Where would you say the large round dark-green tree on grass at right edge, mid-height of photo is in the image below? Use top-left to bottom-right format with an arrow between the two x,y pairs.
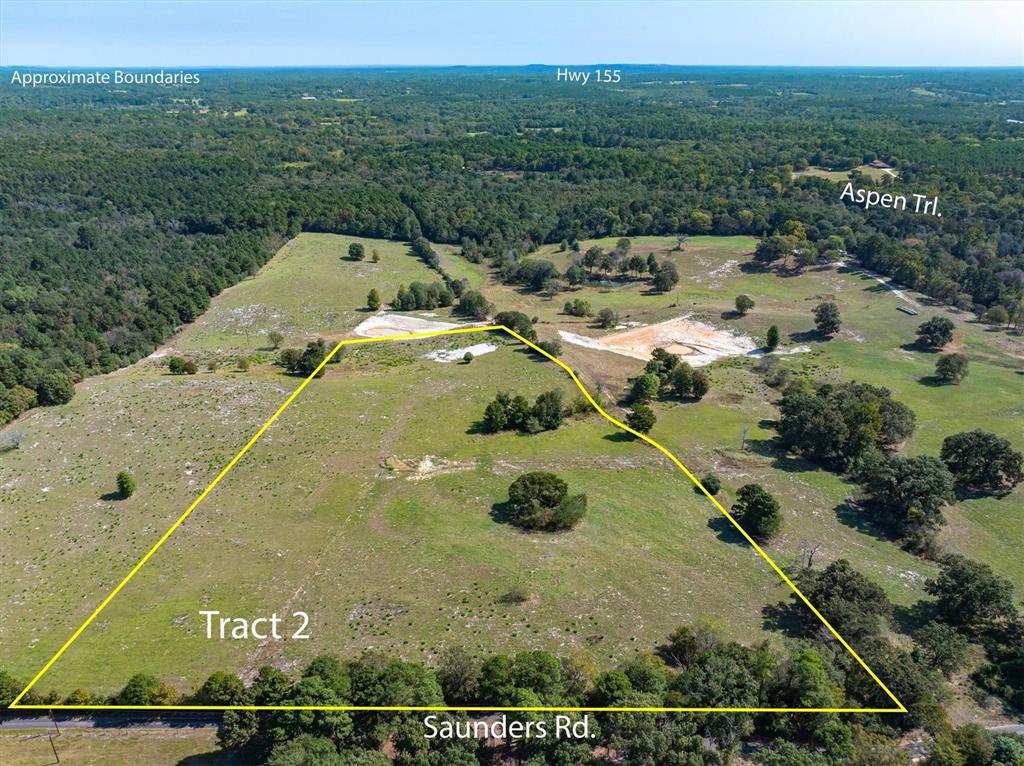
939,429 -> 1024,494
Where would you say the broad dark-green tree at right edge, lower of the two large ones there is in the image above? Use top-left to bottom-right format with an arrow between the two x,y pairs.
925,555 -> 1017,631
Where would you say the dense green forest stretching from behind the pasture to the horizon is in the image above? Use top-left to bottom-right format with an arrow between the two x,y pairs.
0,68 -> 1024,420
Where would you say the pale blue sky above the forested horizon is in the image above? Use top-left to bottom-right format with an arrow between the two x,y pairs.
0,0 -> 1024,68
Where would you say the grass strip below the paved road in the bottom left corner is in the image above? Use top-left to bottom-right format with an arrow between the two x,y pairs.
0,728 -> 224,766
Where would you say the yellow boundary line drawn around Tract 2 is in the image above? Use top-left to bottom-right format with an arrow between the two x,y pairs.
9,325 -> 907,713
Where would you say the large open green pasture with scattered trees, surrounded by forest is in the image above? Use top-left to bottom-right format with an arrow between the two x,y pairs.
0,235 -> 1024,704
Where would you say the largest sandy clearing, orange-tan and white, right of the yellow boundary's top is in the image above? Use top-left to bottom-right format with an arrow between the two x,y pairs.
558,314 -> 758,367
